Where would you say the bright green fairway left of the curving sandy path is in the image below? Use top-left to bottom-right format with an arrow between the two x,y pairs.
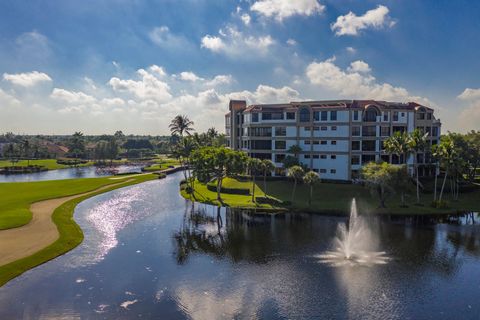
0,177 -> 152,230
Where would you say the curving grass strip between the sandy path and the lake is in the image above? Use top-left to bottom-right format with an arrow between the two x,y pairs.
0,174 -> 158,286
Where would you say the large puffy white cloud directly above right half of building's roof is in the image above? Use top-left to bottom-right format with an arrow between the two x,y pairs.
306,58 -> 432,105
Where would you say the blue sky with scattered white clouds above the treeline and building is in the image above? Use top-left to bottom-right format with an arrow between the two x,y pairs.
0,0 -> 480,135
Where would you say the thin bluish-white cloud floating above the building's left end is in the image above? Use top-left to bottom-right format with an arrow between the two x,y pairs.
201,26 -> 275,57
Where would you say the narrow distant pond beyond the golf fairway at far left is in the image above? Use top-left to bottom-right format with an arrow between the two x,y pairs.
0,166 -> 141,182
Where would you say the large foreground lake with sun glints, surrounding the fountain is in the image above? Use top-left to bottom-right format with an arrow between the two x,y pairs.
0,173 -> 480,319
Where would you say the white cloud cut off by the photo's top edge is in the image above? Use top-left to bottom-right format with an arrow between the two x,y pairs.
250,0 -> 325,21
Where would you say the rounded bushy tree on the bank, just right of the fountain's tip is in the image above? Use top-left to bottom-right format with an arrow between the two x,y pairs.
362,162 -> 396,208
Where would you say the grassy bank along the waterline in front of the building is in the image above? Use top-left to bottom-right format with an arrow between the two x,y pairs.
181,178 -> 480,214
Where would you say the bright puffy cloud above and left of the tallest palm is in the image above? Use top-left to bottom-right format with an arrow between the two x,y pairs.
108,68 -> 172,102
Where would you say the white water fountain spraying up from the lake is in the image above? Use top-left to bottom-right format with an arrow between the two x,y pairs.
317,198 -> 389,266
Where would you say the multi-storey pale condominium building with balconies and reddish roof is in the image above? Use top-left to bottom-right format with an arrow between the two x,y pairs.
225,100 -> 441,181
